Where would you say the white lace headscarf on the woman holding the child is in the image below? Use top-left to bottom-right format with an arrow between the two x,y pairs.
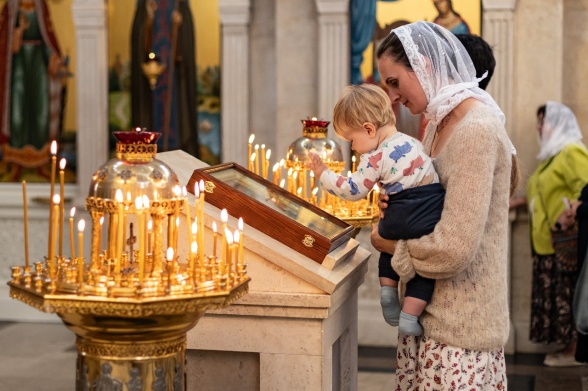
392,21 -> 516,155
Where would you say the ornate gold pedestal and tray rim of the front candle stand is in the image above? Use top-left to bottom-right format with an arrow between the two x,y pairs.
8,277 -> 250,391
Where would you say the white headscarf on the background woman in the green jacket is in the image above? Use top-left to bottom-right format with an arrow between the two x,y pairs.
537,101 -> 582,161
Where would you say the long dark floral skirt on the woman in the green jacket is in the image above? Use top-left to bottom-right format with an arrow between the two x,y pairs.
530,254 -> 577,344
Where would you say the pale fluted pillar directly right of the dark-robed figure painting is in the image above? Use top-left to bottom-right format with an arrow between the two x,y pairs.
219,0 -> 250,166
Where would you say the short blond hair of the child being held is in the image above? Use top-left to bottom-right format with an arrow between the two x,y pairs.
333,84 -> 396,138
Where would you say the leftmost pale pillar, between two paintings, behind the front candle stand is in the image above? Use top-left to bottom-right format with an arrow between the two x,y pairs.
72,0 -> 108,206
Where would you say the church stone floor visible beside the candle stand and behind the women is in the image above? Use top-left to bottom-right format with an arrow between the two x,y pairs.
0,322 -> 588,391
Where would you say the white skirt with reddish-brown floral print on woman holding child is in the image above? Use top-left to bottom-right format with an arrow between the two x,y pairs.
396,335 -> 507,391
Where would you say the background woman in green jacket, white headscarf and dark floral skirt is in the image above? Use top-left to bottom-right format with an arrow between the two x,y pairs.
526,101 -> 588,367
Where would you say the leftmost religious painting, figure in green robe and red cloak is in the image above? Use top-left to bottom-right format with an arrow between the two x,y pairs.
0,0 -> 76,182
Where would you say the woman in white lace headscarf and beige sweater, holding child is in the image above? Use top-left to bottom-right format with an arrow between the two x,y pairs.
372,22 -> 517,390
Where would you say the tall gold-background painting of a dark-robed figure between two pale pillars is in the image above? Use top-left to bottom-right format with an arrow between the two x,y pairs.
108,0 -> 221,164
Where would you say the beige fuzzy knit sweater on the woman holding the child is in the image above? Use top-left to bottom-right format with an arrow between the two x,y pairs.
392,106 -> 512,350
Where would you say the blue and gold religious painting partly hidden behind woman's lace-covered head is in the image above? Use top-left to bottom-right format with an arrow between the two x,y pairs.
350,0 -> 482,139
